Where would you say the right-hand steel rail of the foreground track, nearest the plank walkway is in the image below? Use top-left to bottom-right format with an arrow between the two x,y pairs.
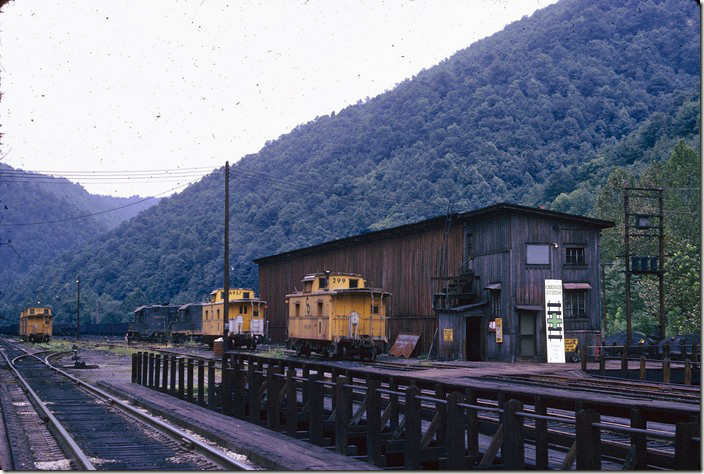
40,353 -> 256,471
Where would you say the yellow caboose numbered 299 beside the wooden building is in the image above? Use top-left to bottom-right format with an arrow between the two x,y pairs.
286,271 -> 391,360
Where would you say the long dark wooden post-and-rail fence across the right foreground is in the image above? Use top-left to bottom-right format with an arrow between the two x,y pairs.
132,353 -> 701,470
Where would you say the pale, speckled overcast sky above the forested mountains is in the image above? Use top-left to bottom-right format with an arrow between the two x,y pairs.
0,0 -> 556,196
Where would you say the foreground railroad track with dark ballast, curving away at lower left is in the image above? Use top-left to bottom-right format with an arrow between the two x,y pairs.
0,341 -> 256,470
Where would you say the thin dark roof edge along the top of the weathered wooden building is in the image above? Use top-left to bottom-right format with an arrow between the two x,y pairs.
254,203 -> 615,264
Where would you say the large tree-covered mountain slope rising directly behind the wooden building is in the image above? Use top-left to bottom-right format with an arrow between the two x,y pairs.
0,0 -> 700,326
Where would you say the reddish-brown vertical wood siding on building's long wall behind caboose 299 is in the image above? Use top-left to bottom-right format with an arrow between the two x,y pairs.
259,222 -> 464,352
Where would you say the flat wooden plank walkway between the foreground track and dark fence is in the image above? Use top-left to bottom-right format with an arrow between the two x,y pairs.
98,382 -> 378,471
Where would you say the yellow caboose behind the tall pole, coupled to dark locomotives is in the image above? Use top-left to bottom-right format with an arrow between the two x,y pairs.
202,288 -> 267,348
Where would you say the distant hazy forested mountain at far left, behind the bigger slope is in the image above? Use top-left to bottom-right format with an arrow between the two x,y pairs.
0,163 -> 157,301
